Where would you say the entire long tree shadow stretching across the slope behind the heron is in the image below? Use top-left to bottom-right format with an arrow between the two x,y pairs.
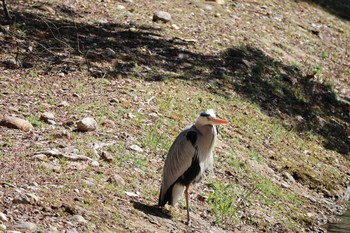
0,1 -> 350,155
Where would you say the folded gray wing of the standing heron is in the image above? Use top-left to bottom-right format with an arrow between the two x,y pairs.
160,127 -> 198,203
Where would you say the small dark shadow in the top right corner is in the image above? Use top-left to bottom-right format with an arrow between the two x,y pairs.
302,0 -> 350,20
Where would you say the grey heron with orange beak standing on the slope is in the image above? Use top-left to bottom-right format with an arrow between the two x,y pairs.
158,109 -> 228,224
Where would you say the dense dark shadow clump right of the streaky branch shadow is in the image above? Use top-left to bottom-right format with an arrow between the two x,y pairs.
219,47 -> 350,155
